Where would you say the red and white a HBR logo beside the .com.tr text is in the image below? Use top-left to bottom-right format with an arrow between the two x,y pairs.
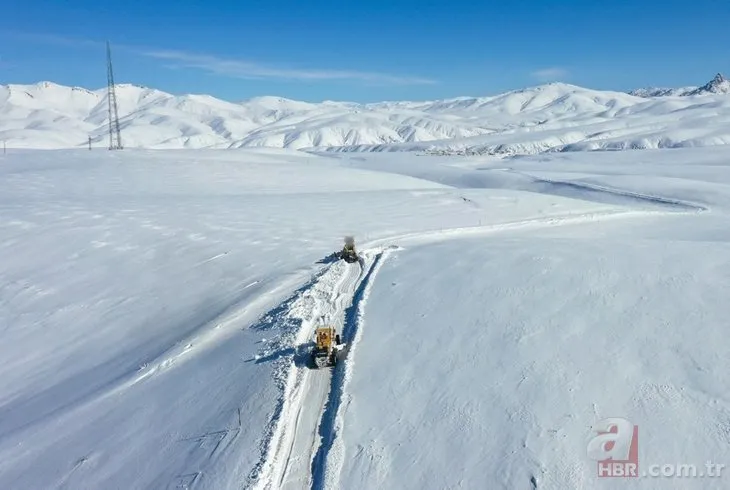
588,417 -> 639,478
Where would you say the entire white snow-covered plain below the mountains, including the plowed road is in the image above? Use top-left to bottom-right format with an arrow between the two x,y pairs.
0,146 -> 730,489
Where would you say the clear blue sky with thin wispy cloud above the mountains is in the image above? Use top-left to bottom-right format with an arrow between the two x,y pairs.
0,0 -> 730,101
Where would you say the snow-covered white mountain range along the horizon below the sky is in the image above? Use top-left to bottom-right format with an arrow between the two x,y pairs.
0,75 -> 730,154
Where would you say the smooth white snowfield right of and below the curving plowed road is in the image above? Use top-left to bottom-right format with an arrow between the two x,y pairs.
329,219 -> 730,489
